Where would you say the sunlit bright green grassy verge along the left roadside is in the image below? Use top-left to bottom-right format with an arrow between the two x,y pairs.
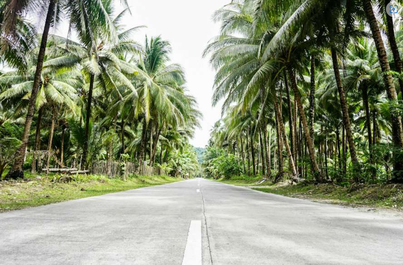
0,175 -> 180,212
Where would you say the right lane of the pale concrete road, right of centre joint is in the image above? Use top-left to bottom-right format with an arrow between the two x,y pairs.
203,182 -> 403,265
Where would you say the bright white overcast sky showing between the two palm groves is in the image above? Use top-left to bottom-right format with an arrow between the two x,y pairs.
52,0 -> 230,147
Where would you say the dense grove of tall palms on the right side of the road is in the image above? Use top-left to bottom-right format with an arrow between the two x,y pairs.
205,0 -> 403,183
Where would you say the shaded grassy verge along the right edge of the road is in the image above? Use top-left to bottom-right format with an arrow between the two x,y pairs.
255,183 -> 403,210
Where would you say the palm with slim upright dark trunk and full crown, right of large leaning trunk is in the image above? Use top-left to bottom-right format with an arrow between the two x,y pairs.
46,10 -> 141,166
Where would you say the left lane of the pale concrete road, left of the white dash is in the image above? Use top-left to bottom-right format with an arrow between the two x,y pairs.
0,181 -> 202,265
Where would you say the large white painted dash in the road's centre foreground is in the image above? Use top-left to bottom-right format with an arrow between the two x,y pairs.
182,220 -> 202,265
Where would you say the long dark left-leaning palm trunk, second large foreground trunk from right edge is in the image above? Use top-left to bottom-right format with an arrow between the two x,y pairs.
331,47 -> 360,181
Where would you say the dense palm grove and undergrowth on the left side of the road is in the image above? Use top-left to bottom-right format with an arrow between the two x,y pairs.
0,0 -> 201,178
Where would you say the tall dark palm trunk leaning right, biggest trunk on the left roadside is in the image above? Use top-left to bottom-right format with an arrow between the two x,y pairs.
5,0 -> 56,179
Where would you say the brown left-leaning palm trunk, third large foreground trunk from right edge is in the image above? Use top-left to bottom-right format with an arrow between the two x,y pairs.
288,66 -> 322,182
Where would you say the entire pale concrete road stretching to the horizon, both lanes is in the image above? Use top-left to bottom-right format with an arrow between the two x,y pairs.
0,180 -> 403,265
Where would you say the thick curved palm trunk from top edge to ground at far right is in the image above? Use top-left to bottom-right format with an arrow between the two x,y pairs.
363,0 -> 403,183
